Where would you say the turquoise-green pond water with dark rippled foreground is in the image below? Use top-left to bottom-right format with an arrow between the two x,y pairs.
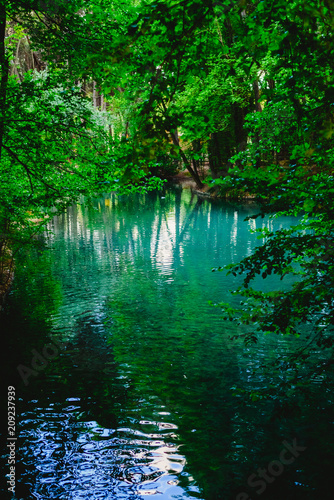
2,187 -> 334,500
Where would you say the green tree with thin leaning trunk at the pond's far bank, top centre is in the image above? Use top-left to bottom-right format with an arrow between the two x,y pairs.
88,1 -> 236,187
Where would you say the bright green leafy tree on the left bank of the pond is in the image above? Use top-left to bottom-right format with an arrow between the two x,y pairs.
0,0 -> 162,296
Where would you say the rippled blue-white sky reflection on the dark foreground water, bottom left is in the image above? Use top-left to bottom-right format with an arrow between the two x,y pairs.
20,398 -> 187,499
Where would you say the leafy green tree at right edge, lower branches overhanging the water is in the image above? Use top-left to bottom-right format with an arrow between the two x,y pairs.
211,1 -> 334,392
